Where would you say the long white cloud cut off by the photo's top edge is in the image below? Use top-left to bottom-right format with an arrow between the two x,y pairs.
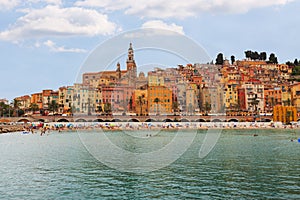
75,0 -> 295,19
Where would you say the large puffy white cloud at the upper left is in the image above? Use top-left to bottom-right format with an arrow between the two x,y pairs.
0,5 -> 117,42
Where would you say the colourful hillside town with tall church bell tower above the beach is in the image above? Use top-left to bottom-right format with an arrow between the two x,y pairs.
0,43 -> 300,123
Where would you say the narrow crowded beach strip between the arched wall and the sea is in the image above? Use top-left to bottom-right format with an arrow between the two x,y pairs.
0,122 -> 300,134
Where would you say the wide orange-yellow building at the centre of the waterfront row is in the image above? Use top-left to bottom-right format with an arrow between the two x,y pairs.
148,86 -> 172,115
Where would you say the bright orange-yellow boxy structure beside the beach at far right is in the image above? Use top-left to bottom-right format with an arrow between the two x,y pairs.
273,105 -> 298,124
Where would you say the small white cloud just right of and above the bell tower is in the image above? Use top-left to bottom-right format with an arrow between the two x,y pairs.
142,20 -> 184,35
